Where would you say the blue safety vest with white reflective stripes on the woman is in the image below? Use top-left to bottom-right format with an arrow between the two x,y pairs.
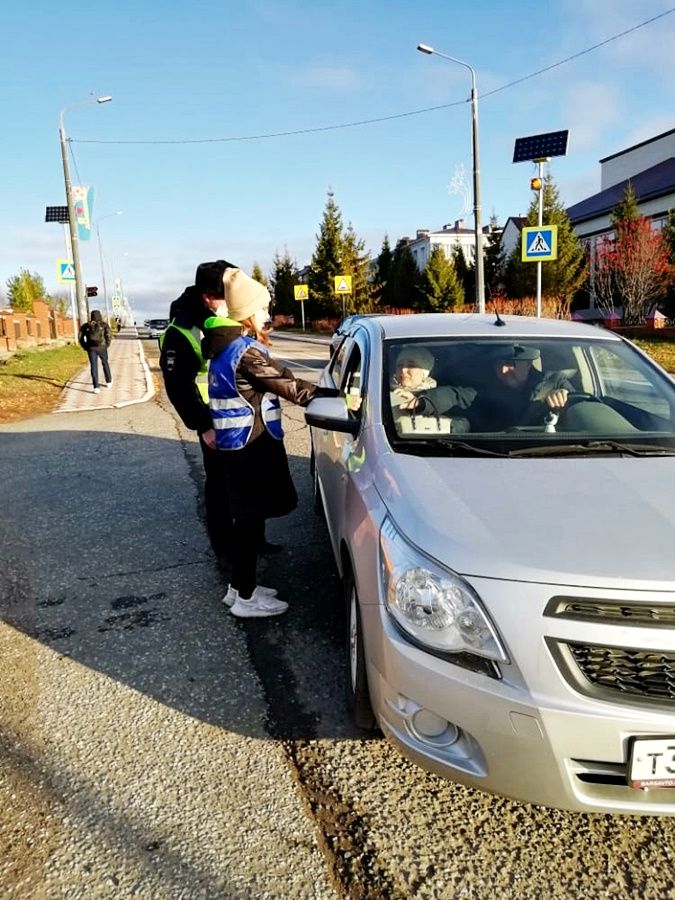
209,335 -> 284,450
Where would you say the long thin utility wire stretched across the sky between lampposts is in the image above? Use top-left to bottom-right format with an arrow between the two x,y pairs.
74,6 -> 675,144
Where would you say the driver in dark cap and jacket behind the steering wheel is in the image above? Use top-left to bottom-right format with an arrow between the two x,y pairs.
468,344 -> 574,431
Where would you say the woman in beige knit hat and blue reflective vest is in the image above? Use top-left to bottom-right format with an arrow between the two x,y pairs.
202,268 -> 336,617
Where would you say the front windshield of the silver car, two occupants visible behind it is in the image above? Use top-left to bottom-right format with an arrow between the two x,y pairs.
383,336 -> 675,455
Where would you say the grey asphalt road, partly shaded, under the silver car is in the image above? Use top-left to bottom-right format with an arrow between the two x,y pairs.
0,338 -> 675,898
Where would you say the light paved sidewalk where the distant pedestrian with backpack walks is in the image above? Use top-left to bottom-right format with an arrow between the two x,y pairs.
54,328 -> 155,413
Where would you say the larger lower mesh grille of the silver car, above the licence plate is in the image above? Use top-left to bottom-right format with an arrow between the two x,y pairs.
566,643 -> 675,702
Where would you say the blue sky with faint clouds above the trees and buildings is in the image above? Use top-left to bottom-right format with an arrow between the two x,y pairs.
0,0 -> 675,320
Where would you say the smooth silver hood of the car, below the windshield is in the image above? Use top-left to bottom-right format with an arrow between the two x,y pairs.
375,453 -> 675,590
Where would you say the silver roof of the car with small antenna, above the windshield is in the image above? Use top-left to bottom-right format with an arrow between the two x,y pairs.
354,313 -> 621,342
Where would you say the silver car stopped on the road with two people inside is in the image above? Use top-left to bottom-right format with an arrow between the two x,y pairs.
306,314 -> 675,815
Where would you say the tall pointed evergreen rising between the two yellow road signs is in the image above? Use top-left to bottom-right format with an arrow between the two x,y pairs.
307,191 -> 349,318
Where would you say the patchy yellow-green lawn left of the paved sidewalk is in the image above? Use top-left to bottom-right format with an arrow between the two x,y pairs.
0,344 -> 88,422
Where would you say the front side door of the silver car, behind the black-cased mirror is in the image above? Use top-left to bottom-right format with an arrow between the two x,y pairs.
313,333 -> 366,559
